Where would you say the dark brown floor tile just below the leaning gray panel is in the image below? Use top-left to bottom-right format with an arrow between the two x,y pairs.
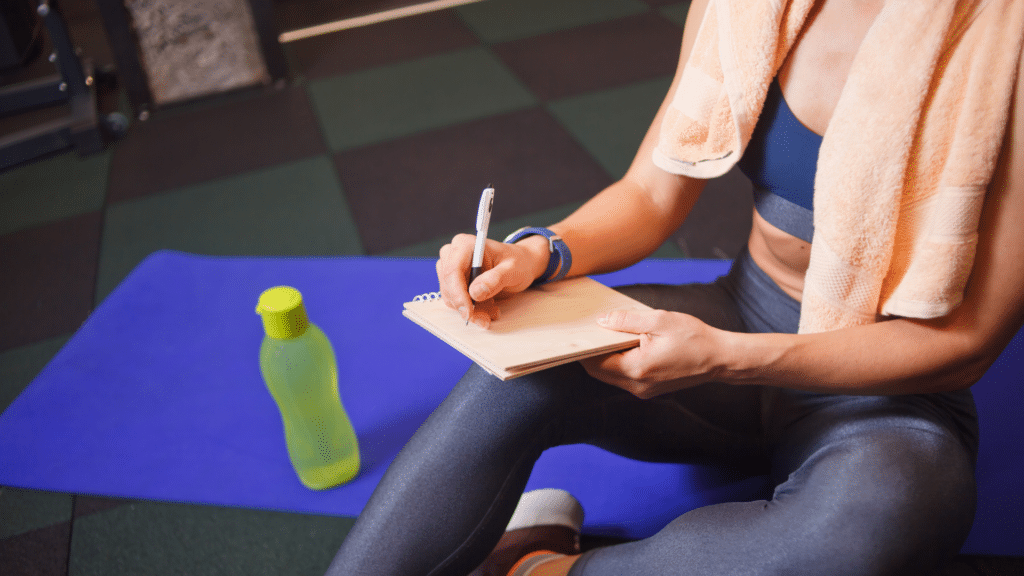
110,87 -> 326,201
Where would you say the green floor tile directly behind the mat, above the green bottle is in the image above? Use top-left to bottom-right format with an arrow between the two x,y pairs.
96,157 -> 362,302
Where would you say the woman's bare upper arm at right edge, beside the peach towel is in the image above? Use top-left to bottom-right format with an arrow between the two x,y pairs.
943,51 -> 1024,369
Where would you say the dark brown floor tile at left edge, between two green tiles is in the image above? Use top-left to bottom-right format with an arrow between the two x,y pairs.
0,212 -> 101,351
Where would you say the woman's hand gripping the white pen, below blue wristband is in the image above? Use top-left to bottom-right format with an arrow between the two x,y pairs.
437,234 -> 550,328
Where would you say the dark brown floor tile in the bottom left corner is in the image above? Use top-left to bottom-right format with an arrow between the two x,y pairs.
0,522 -> 71,576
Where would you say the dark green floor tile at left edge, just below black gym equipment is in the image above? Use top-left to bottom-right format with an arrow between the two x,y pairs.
0,153 -> 111,234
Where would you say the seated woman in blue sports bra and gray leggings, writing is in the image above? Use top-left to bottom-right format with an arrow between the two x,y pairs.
330,0 -> 1024,576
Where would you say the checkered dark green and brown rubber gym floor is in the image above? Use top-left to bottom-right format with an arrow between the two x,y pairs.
0,0 -> 1024,576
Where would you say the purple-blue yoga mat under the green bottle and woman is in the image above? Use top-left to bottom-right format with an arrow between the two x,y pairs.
0,251 -> 1024,554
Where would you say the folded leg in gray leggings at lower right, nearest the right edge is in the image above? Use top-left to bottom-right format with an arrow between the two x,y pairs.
570,399 -> 975,576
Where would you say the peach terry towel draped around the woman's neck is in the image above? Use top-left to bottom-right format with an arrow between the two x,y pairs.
653,0 -> 1024,333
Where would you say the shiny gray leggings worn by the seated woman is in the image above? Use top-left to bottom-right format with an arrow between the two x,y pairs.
328,253 -> 978,576
